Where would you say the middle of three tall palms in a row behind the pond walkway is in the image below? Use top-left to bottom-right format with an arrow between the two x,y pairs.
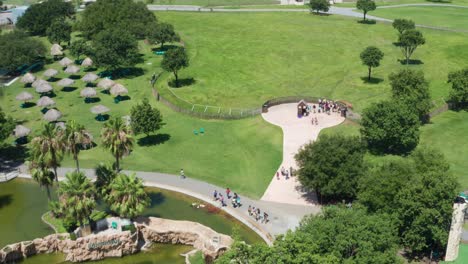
64,120 -> 92,172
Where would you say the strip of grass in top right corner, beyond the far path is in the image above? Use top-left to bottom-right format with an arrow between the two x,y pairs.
370,6 -> 468,30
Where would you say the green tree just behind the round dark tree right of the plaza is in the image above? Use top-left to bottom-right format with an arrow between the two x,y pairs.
389,69 -> 432,123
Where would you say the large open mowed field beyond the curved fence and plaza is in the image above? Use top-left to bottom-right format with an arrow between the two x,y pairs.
156,12 -> 468,112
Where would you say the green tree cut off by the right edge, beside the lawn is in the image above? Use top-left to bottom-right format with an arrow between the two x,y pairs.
448,68 -> 468,108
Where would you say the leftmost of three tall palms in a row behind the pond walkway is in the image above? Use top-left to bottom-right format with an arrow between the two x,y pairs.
31,123 -> 65,181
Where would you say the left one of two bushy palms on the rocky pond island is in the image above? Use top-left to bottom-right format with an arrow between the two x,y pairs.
58,172 -> 96,226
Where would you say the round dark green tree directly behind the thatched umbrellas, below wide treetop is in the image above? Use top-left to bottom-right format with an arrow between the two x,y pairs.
92,28 -> 139,70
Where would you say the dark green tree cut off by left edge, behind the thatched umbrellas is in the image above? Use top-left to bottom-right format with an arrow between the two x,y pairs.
0,31 -> 46,71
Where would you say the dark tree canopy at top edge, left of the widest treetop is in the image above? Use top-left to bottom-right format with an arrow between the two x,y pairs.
16,0 -> 75,36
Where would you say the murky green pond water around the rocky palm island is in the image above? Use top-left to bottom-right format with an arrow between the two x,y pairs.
0,179 -> 263,264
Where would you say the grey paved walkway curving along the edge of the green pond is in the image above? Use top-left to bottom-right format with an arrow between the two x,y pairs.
15,166 -> 320,242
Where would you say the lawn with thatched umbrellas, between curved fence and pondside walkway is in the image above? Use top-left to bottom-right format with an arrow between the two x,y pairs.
0,42 -> 282,198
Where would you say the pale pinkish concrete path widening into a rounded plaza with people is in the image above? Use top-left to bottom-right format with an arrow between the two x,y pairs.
262,103 -> 345,206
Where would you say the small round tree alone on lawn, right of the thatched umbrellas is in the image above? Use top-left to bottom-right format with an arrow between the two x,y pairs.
130,98 -> 164,136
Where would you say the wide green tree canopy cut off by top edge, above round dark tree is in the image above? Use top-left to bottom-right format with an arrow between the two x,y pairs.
78,0 -> 156,39
